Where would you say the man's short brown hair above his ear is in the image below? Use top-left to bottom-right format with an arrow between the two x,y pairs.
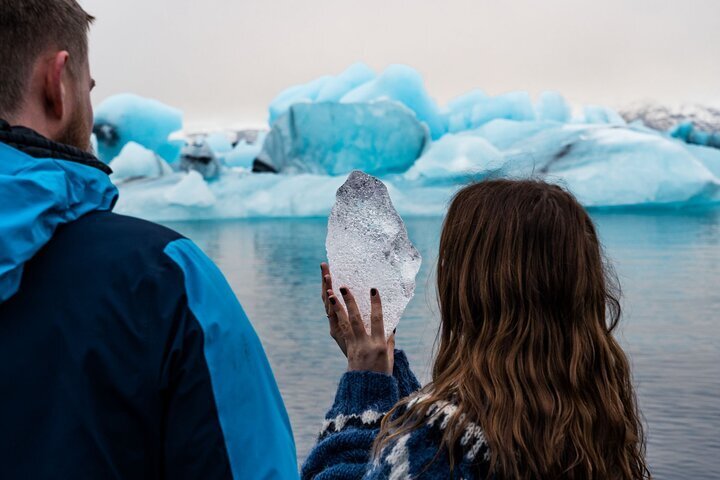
0,0 -> 94,117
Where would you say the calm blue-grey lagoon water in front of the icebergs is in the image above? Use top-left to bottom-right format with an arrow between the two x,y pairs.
170,211 -> 720,479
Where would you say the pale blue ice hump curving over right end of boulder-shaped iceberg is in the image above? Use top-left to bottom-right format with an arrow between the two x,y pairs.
341,65 -> 447,140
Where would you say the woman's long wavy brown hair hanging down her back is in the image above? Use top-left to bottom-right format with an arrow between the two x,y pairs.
375,180 -> 650,480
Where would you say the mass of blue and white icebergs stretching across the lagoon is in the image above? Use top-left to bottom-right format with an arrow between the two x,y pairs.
94,64 -> 720,221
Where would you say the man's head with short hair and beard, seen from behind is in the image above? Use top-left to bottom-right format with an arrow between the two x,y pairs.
0,0 -> 95,150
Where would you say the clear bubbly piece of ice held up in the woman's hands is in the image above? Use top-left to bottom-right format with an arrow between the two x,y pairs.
326,171 -> 422,337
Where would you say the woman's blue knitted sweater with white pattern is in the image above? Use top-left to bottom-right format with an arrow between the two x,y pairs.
302,351 -> 489,480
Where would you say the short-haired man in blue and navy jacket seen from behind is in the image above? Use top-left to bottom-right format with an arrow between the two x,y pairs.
0,0 -> 297,479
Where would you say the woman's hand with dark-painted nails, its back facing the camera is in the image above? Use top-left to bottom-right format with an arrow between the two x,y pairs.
327,287 -> 395,375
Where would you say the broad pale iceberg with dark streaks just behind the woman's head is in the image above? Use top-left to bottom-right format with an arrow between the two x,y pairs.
474,122 -> 720,207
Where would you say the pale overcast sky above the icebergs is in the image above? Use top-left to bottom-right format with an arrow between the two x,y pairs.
80,0 -> 720,127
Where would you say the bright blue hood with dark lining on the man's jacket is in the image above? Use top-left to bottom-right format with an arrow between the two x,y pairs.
0,120 -> 118,303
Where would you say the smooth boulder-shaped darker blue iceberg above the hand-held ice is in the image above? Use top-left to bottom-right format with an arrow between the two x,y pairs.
255,102 -> 429,175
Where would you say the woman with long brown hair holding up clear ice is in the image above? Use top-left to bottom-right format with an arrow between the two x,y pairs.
302,180 -> 650,480
